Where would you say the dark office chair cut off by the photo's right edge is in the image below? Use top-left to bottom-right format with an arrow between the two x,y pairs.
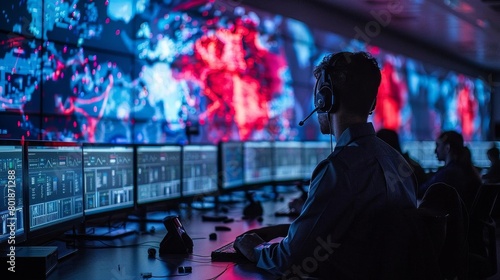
469,183 -> 500,279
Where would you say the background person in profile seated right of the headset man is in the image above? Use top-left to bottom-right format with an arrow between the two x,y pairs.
418,130 -> 481,209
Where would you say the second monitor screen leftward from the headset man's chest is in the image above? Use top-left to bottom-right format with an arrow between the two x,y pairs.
273,141 -> 304,181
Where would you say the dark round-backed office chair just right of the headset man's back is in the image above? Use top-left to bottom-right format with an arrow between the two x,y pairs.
419,183 -> 469,279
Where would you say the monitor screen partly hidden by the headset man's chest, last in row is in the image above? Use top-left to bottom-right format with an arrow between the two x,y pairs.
302,141 -> 332,180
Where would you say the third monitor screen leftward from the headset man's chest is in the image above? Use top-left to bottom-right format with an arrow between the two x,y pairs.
243,141 -> 273,185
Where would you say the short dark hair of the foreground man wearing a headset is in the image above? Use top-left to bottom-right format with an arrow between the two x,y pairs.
314,52 -> 382,116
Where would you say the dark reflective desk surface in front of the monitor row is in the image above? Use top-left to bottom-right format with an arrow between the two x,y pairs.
47,188 -> 300,280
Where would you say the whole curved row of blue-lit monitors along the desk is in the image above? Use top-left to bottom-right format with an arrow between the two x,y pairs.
0,140 -> 331,247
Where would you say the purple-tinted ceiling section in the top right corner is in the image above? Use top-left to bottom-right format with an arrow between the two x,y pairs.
316,0 -> 500,73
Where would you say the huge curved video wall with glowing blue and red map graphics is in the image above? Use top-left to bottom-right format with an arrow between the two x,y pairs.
0,0 -> 491,143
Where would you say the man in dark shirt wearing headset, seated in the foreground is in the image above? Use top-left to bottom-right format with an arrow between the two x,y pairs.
234,52 -> 432,279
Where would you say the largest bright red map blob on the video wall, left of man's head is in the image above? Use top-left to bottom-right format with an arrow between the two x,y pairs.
179,18 -> 287,140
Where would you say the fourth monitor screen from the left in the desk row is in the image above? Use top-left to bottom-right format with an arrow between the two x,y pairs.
137,145 -> 182,204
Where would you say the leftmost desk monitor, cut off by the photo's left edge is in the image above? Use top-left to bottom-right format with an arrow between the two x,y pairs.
0,140 -> 26,248
